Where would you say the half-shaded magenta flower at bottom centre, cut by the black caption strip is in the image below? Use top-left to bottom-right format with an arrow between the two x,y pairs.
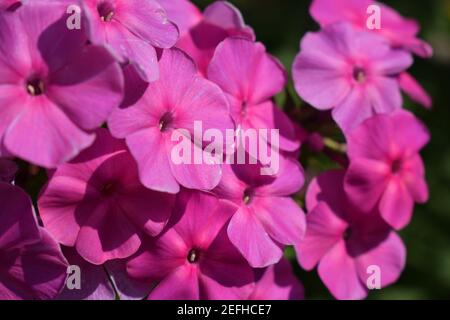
127,190 -> 254,300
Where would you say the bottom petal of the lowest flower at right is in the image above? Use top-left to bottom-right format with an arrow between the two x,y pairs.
319,240 -> 368,300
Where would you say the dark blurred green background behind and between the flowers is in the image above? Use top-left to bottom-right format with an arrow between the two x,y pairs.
193,0 -> 450,299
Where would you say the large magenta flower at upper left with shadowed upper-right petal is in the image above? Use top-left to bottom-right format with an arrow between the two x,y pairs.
0,1 -> 123,168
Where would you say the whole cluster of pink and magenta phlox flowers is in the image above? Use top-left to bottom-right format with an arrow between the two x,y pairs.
0,0 -> 432,299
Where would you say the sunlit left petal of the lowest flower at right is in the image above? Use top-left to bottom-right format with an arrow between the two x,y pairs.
295,202 -> 348,270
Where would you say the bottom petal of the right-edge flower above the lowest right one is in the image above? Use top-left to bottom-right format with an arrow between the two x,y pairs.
379,177 -> 414,230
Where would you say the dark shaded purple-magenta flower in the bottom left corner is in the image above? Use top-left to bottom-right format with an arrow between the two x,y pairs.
0,182 -> 67,300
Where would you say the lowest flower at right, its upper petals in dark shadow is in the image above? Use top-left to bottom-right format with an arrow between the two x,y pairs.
295,171 -> 406,299
